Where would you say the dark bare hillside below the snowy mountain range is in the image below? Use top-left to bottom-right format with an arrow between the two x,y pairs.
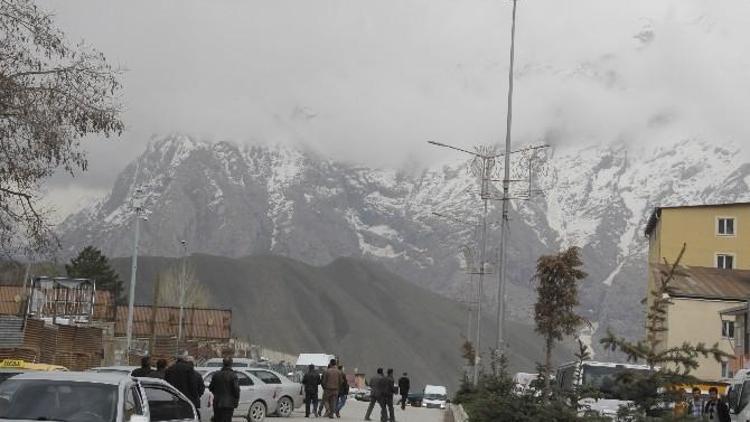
113,254 -> 568,387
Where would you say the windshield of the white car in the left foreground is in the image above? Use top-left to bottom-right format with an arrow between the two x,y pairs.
0,379 -> 117,422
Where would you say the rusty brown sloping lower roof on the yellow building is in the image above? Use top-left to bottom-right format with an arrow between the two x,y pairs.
650,264 -> 750,301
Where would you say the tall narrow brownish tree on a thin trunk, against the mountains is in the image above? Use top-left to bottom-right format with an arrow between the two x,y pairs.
534,247 -> 586,395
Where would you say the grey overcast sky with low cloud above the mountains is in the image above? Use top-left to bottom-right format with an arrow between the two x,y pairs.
41,0 -> 750,211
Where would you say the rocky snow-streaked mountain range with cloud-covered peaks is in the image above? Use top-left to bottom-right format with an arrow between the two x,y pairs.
60,135 -> 750,356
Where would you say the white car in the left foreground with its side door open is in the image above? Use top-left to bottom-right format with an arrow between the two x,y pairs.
0,372 -> 199,422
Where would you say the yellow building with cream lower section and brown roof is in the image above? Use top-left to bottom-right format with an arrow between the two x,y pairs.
646,203 -> 750,381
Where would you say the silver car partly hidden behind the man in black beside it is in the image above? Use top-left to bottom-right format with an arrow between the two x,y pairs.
195,367 -> 279,422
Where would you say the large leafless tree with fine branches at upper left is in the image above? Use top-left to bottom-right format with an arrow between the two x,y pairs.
0,0 -> 123,255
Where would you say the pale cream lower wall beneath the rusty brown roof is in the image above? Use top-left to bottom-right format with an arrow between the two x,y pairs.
664,298 -> 741,381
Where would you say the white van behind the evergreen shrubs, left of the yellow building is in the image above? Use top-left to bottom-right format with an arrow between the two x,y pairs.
555,360 -> 650,419
